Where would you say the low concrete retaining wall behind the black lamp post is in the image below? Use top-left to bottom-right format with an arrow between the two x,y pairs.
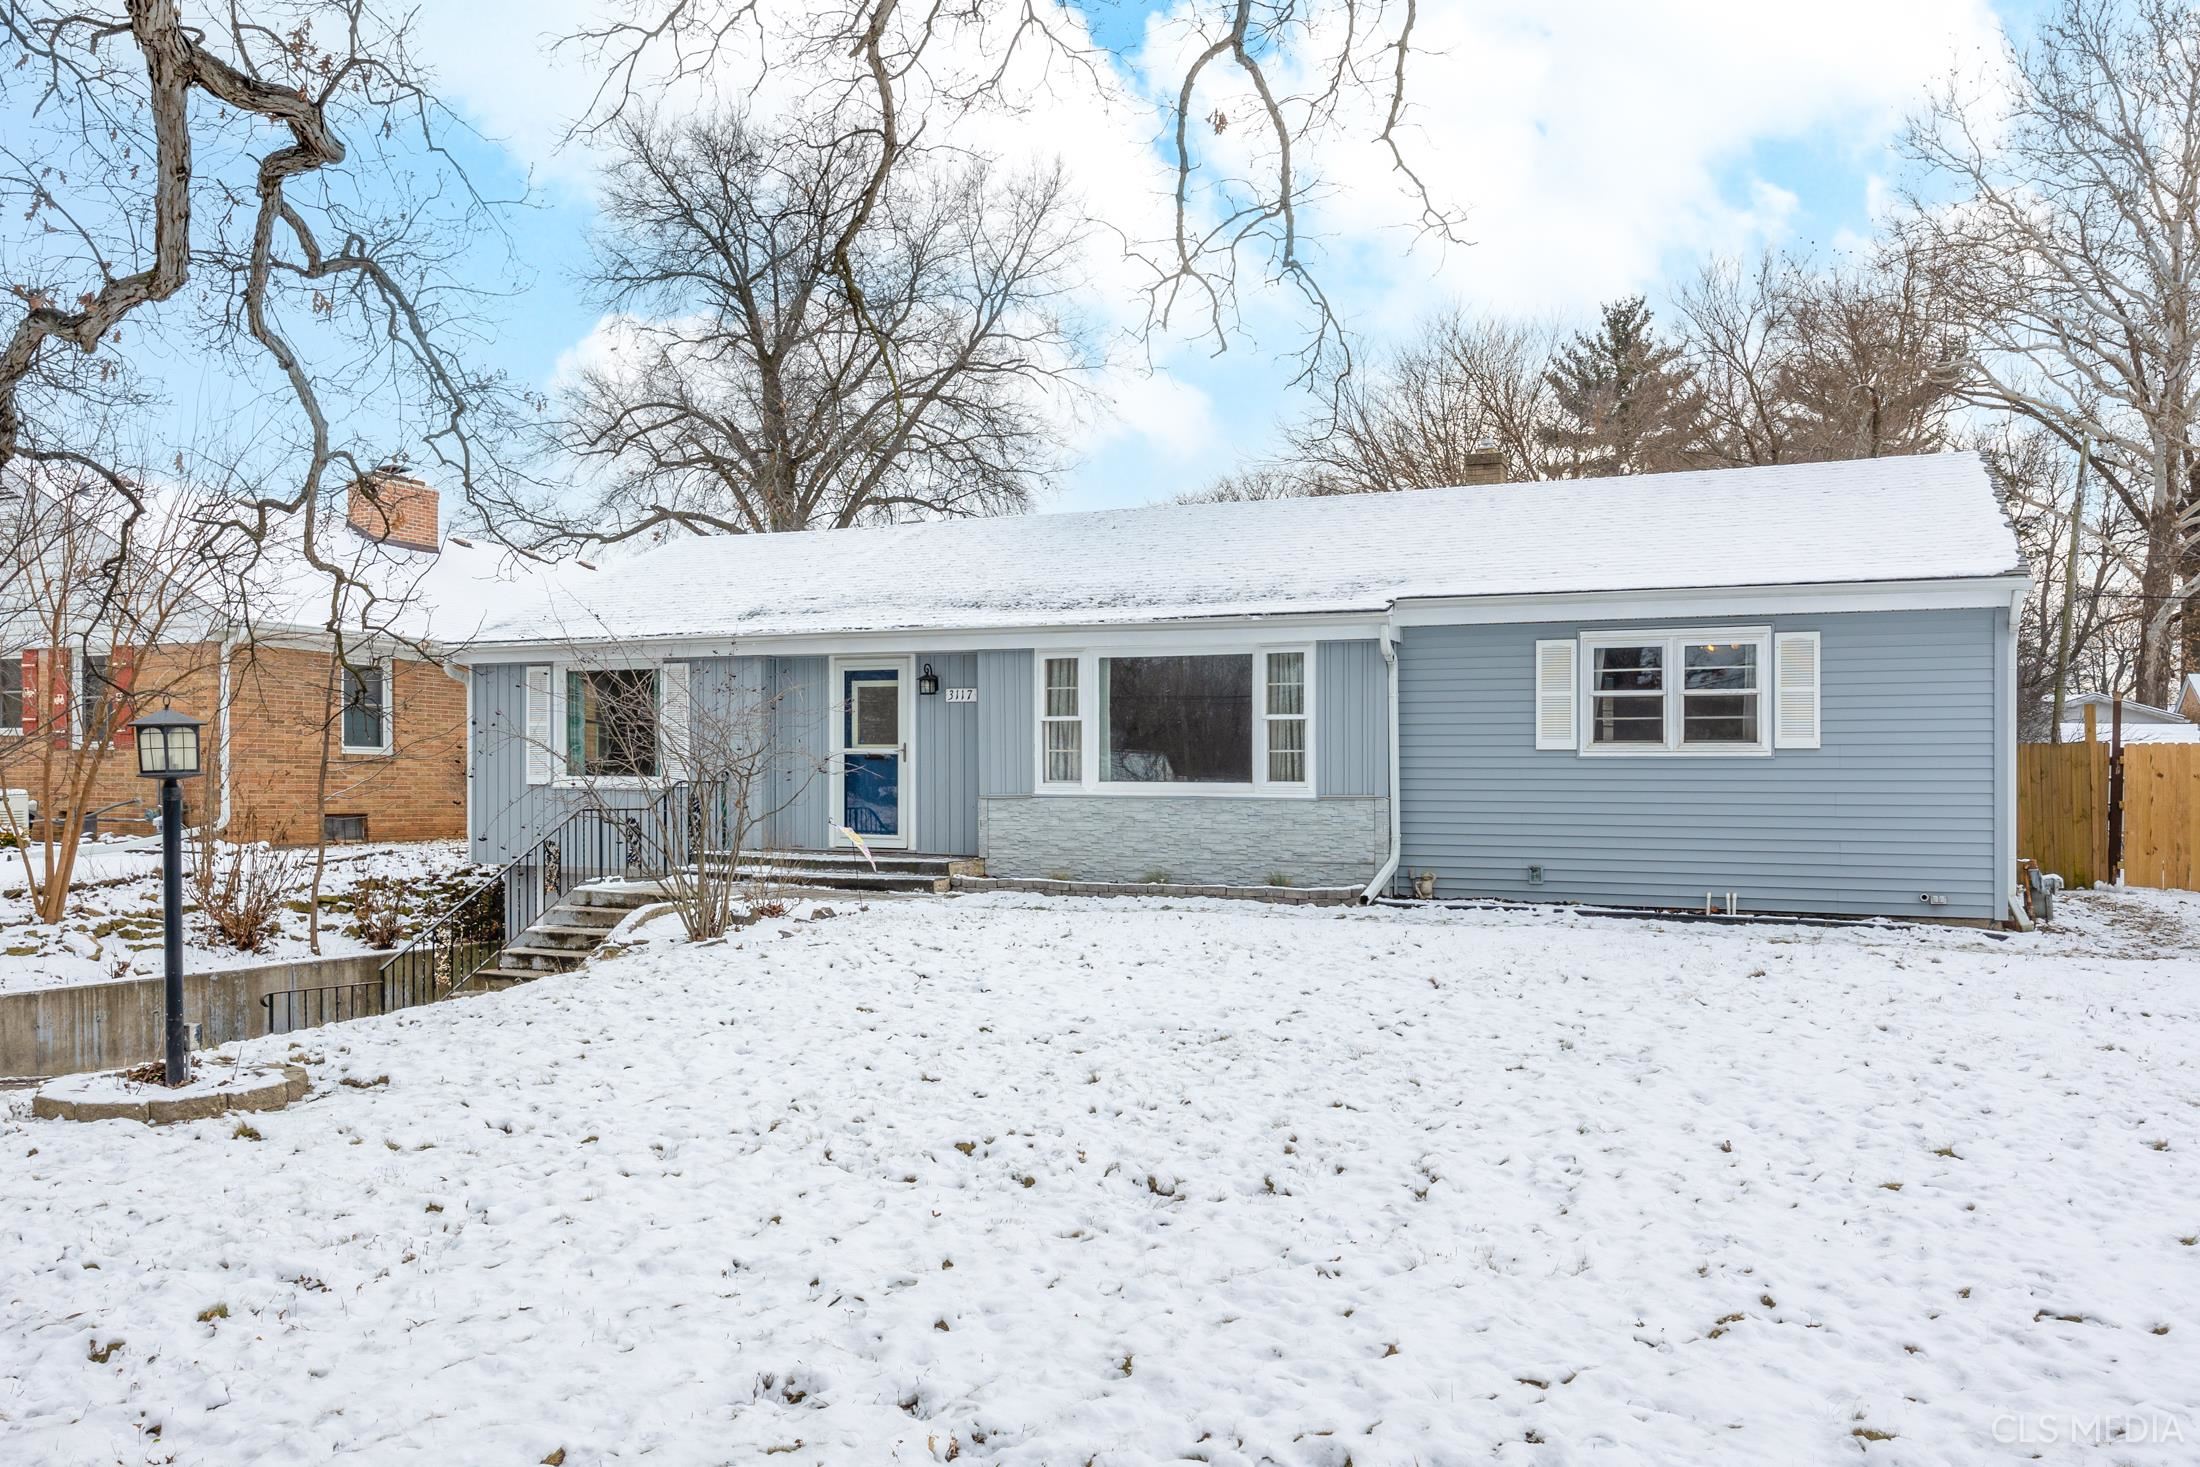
0,952 -> 389,1078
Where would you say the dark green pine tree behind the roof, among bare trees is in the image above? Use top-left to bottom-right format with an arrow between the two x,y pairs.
1542,295 -> 1705,477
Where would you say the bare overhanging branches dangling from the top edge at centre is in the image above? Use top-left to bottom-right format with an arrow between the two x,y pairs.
568,0 -> 1461,380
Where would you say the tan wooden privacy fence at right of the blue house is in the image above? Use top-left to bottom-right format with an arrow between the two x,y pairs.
2017,743 -> 2200,891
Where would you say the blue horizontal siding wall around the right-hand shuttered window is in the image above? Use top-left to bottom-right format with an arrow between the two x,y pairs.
1399,609 -> 2013,919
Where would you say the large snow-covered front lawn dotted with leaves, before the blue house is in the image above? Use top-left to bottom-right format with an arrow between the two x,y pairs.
0,895 -> 2200,1467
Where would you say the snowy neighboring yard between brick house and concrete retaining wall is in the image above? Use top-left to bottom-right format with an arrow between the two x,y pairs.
0,836 -> 471,994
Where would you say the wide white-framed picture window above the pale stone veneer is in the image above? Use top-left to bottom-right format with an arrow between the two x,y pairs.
1038,647 -> 1313,794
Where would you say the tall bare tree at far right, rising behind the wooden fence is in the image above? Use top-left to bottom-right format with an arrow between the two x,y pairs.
1905,0 -> 2200,702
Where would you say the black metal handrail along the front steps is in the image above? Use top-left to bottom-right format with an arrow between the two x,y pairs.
262,781 -> 733,1034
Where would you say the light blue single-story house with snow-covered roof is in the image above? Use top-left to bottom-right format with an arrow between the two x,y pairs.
458,453 -> 2026,922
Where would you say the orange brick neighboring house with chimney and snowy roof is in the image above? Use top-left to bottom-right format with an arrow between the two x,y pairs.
0,471 -> 532,845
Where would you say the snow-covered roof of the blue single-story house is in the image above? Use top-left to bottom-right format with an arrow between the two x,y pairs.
482,453 -> 2022,642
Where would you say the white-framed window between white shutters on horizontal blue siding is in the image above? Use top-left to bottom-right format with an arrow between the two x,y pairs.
1582,629 -> 1771,754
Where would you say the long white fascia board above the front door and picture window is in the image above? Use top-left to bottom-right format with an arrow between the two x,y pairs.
451,611 -> 1384,664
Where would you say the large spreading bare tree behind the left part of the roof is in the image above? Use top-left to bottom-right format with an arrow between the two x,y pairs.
561,112 -> 1091,539
